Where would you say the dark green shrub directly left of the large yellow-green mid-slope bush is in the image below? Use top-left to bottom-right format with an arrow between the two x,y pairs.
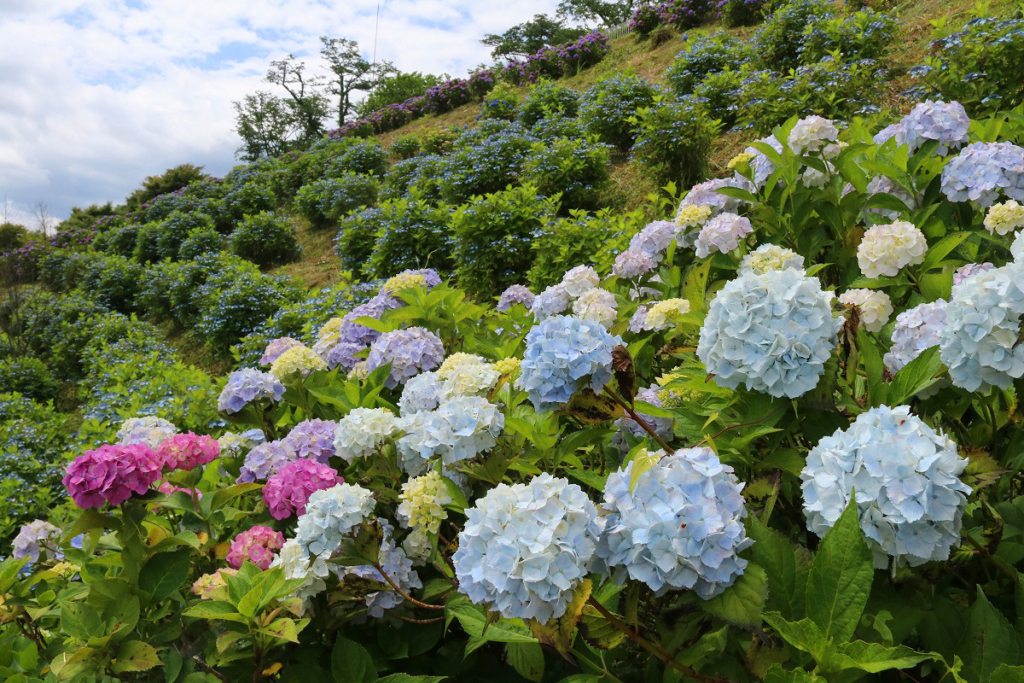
364,197 -> 452,278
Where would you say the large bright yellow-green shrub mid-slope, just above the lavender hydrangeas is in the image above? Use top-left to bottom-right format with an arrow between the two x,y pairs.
452,185 -> 557,296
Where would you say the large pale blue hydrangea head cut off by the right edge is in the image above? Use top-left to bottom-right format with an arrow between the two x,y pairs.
939,262 -> 1024,391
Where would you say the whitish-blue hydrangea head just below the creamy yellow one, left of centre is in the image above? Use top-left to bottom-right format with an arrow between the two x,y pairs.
395,396 -> 505,476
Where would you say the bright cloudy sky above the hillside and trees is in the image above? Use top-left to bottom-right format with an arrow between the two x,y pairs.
0,0 -> 558,225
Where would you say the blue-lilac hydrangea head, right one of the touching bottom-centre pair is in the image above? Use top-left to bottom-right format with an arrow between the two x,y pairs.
597,449 -> 754,600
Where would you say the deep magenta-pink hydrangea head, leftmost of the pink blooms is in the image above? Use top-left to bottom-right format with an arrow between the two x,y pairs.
63,443 -> 162,509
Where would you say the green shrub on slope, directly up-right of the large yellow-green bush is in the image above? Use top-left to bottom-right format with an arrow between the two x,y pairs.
522,137 -> 611,209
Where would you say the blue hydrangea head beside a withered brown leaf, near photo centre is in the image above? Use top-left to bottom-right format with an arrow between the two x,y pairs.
518,315 -> 623,412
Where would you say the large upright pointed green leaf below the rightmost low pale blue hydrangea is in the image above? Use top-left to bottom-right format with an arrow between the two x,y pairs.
806,497 -> 874,643
